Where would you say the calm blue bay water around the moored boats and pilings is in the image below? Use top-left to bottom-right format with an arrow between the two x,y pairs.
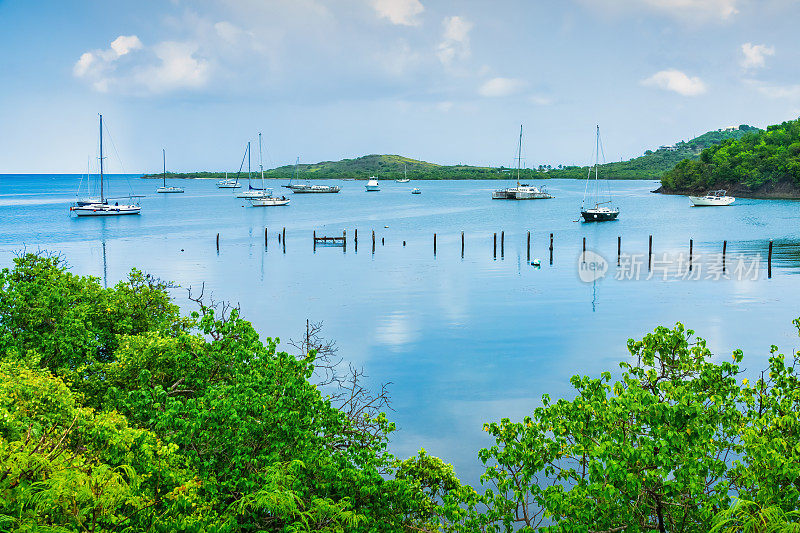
0,176 -> 800,482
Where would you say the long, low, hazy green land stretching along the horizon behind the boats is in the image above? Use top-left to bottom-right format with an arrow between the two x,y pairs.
142,124 -> 761,180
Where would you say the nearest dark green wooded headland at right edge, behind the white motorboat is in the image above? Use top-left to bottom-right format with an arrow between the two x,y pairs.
659,120 -> 800,198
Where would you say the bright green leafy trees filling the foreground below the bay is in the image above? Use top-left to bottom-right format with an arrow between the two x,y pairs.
0,254 -> 800,533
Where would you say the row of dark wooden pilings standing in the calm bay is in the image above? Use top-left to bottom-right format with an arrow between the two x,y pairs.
217,227 -> 773,278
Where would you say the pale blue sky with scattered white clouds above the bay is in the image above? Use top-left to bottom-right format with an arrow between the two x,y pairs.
0,0 -> 800,173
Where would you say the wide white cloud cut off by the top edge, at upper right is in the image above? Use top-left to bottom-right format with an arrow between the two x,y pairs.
579,0 -> 742,22
